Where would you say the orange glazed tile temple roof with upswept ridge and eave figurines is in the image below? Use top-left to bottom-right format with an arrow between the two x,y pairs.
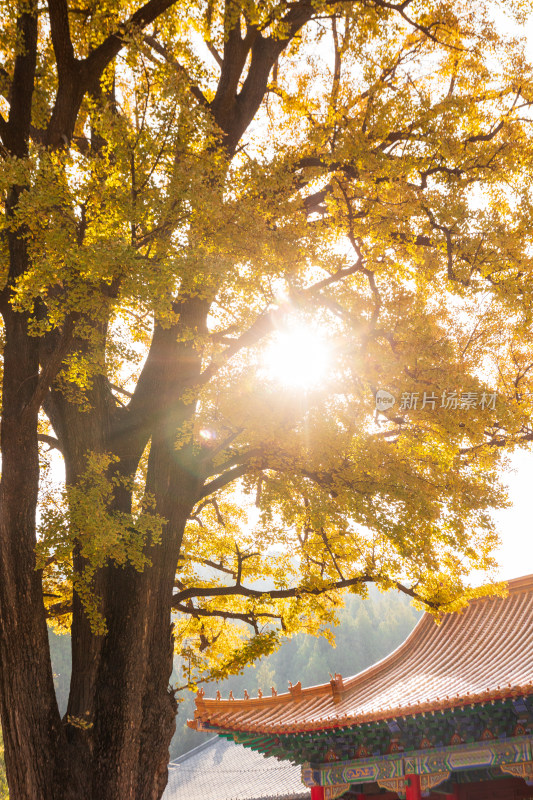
189,575 -> 533,734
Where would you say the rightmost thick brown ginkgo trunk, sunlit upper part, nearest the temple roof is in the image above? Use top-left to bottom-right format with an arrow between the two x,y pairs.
88,310 -> 208,800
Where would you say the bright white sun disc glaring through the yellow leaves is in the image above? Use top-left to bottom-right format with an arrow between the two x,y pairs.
261,325 -> 331,389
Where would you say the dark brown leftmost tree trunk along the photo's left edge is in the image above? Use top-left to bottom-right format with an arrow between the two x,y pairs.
0,258 -> 67,800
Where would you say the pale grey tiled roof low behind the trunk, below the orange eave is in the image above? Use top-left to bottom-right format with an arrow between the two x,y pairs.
162,736 -> 310,800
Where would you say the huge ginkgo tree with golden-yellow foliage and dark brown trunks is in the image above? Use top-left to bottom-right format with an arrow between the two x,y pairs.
0,0 -> 533,800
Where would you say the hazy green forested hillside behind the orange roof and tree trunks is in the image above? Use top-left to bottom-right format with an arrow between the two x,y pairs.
0,588 -> 420,800
